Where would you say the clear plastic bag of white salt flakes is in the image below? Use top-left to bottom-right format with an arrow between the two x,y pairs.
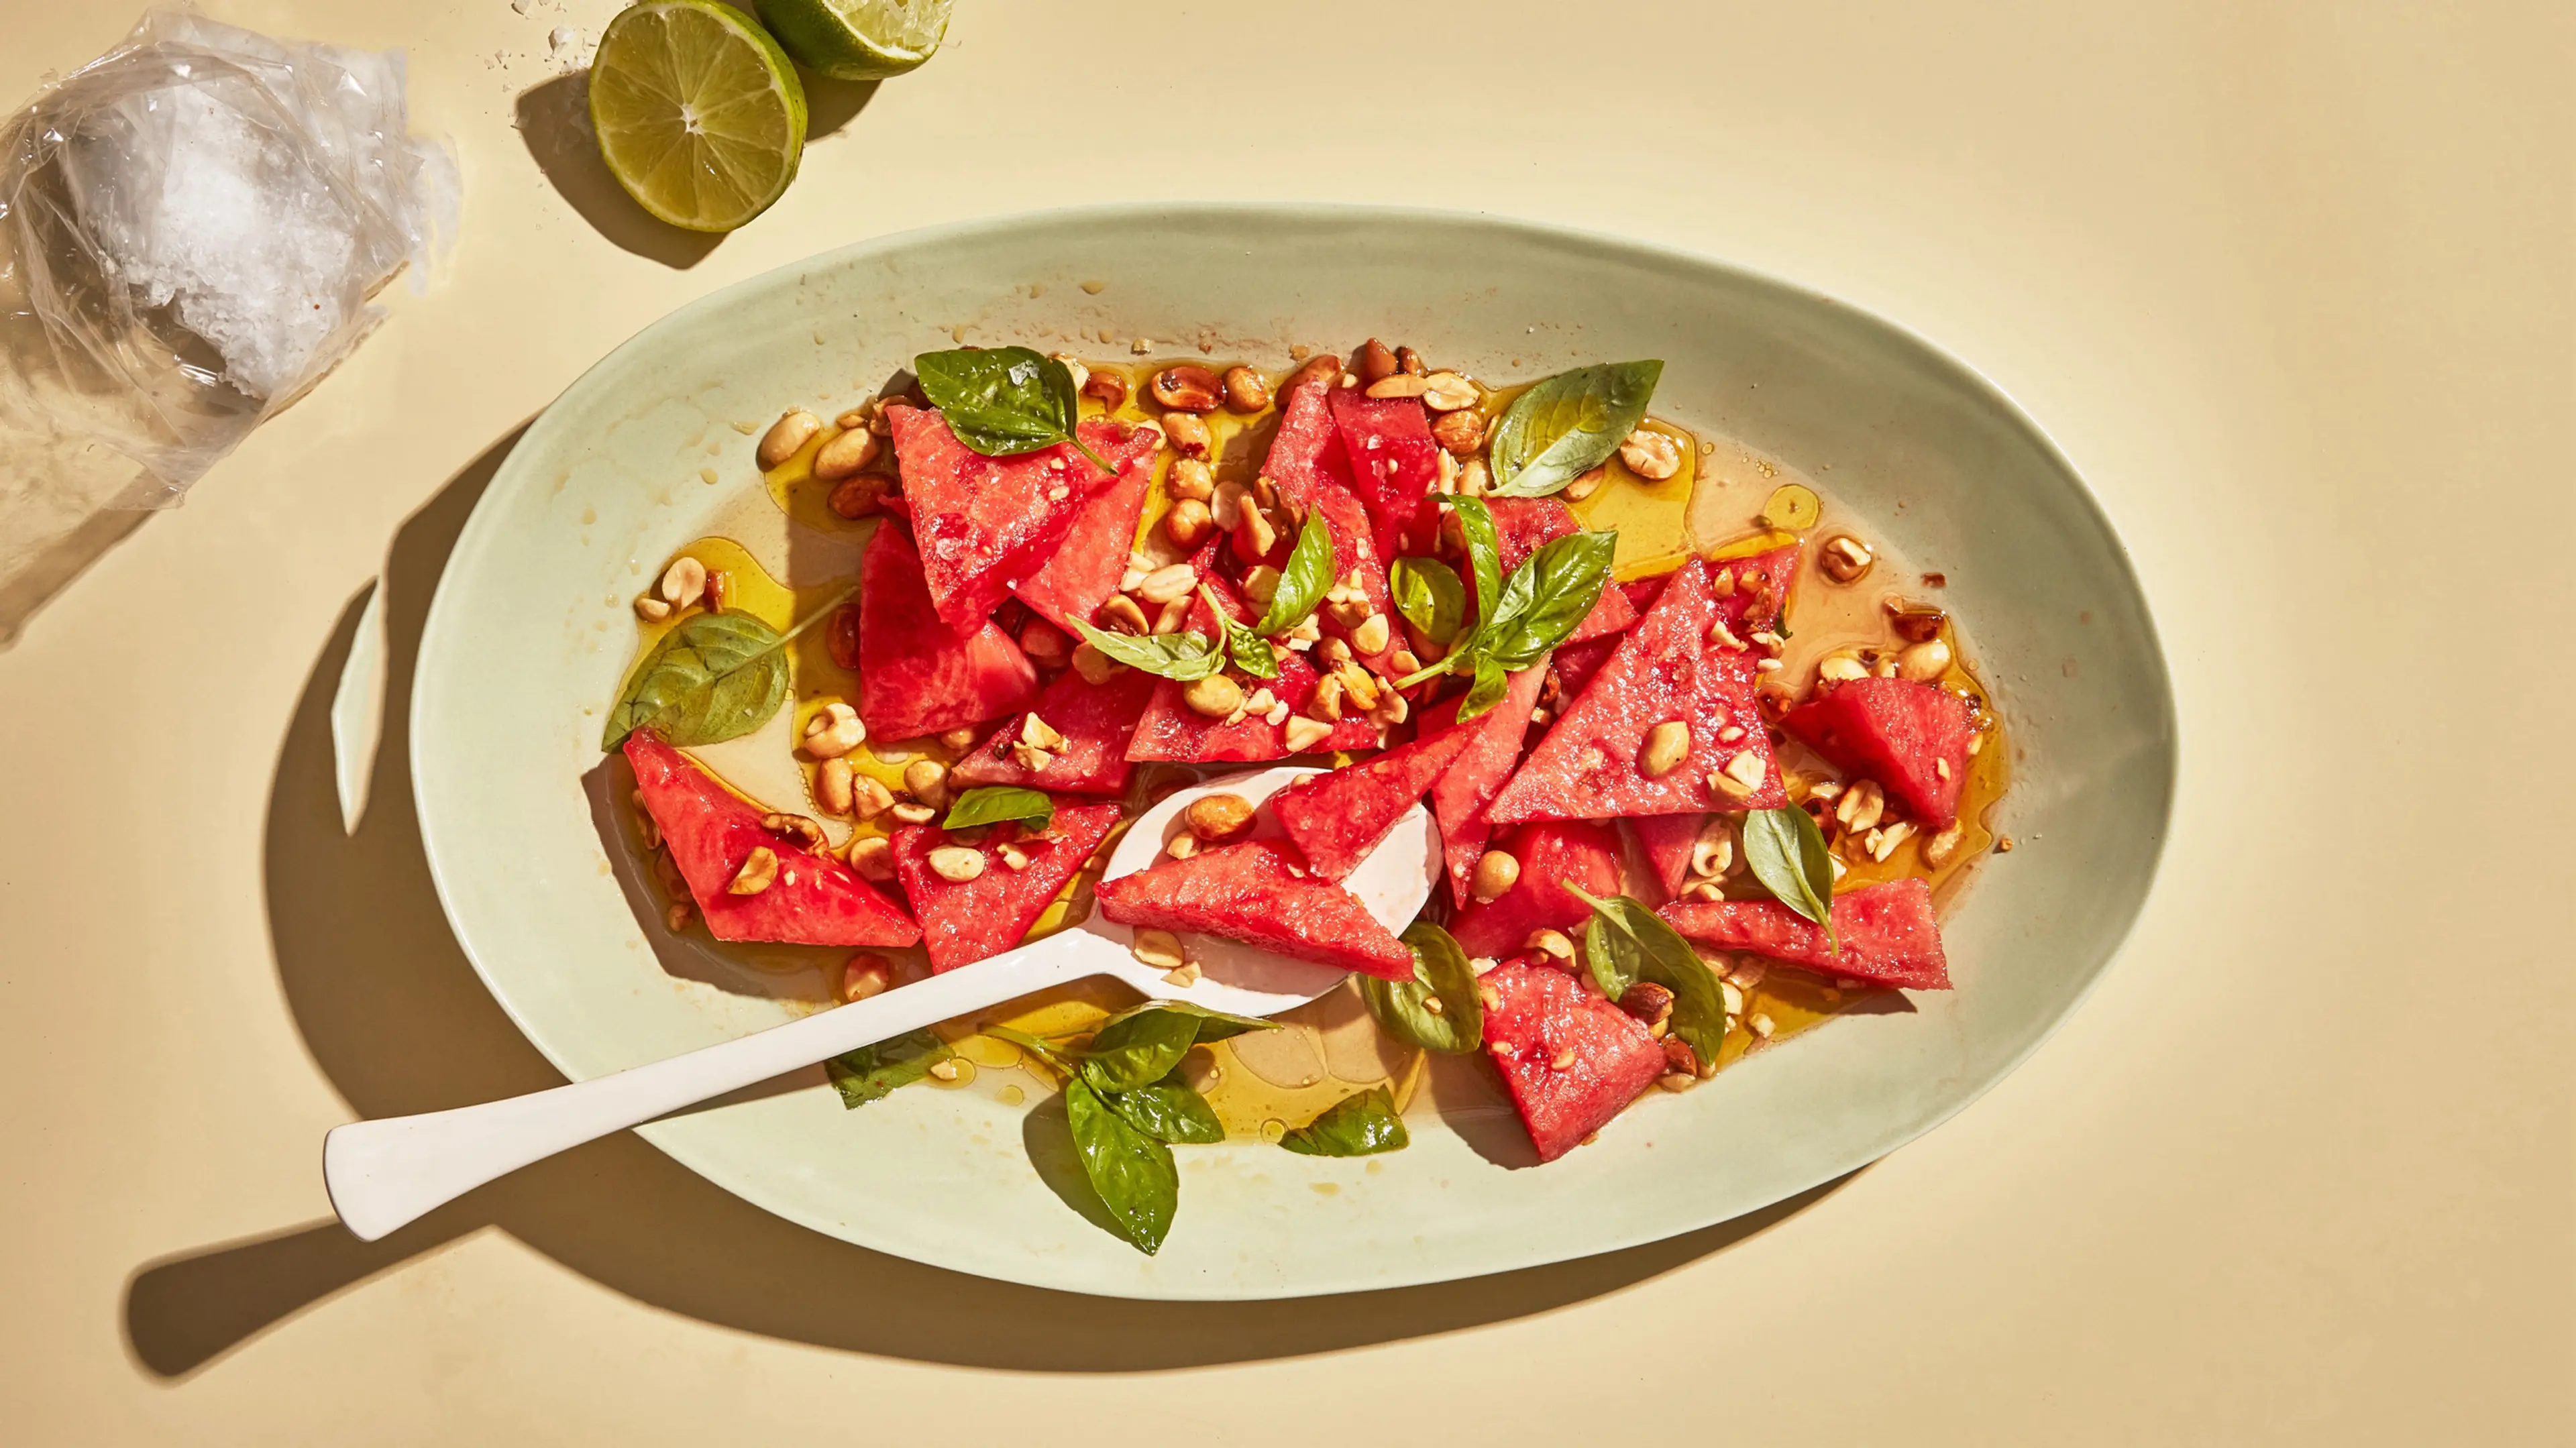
0,10 -> 459,639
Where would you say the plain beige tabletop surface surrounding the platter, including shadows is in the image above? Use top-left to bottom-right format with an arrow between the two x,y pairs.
0,0 -> 2576,1445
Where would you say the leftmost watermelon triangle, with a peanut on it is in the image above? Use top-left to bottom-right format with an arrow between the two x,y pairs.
626,729 -> 922,946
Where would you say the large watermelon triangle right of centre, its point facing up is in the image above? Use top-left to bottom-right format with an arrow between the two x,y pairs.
1489,559 -> 1788,824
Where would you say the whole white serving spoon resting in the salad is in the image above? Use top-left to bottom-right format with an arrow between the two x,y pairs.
322,765 -> 1440,1242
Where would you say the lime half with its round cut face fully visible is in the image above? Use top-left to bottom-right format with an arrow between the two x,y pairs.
590,0 -> 806,232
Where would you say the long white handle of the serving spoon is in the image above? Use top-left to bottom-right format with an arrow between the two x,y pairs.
322,930 -> 1123,1242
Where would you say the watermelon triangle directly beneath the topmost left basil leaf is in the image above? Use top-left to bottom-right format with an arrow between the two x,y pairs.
886,404 -> 1128,634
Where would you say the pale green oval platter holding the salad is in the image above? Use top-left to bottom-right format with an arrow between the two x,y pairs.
412,206 -> 2177,1298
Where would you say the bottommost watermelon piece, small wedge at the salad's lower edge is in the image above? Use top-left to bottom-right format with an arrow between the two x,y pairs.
1476,964 -> 1664,1162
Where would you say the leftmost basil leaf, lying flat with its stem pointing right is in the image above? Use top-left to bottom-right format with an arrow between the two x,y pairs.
600,585 -> 858,753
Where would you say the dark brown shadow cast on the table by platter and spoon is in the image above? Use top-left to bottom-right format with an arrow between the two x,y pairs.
123,431 -> 1849,1378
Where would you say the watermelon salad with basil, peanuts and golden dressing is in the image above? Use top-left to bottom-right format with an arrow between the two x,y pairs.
603,340 -> 2012,1252
